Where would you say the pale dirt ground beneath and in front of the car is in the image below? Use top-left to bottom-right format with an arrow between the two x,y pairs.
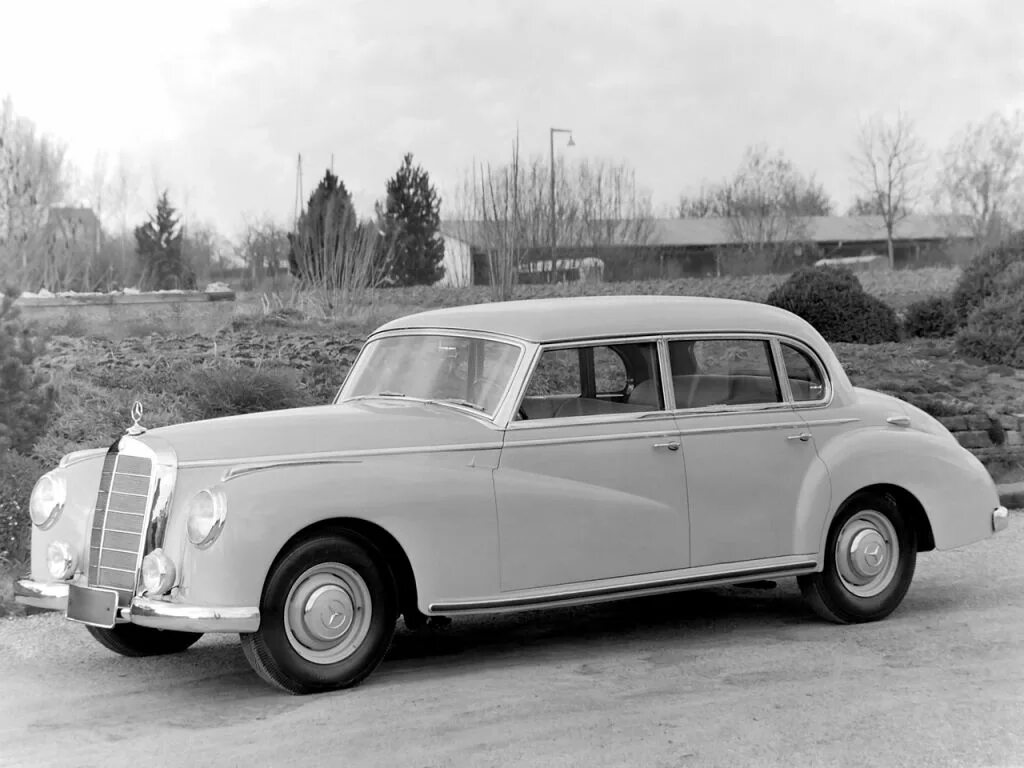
0,513 -> 1024,768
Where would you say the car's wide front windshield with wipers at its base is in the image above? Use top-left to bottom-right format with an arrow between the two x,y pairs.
339,334 -> 520,416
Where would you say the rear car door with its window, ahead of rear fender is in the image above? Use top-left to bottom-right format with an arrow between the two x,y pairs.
668,335 -> 820,566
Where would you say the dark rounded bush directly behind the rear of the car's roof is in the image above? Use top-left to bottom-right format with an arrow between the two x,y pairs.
767,267 -> 899,344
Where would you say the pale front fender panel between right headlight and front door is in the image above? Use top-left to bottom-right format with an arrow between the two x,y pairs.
179,451 -> 499,611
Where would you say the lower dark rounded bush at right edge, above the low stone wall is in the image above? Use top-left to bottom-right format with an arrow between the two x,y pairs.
956,261 -> 1024,368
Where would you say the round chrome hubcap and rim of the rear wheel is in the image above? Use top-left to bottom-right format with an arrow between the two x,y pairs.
836,510 -> 899,597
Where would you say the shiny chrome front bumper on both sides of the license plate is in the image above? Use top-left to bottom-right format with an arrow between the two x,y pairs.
14,579 -> 259,633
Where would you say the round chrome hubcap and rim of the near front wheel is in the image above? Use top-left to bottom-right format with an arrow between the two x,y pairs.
285,563 -> 372,664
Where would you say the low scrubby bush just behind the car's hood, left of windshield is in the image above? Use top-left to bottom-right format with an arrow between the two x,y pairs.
181,362 -> 312,419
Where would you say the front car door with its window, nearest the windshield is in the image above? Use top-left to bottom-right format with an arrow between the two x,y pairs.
495,339 -> 689,591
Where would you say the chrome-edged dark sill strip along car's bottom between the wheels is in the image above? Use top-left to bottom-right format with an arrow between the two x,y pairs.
430,560 -> 817,613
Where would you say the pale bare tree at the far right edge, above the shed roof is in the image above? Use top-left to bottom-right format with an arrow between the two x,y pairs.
937,111 -> 1024,248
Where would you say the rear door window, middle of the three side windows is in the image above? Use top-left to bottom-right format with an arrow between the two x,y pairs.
669,338 -> 782,409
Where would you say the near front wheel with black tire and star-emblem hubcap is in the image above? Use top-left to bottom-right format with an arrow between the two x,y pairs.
241,531 -> 398,694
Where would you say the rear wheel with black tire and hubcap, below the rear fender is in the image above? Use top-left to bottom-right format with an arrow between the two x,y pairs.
797,492 -> 918,624
